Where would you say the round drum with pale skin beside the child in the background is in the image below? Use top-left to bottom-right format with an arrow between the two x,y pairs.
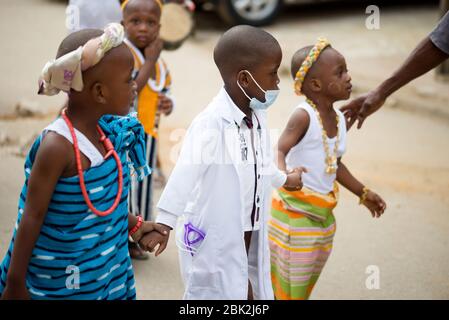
159,2 -> 194,50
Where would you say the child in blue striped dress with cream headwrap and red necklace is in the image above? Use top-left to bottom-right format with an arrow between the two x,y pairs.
0,24 -> 167,299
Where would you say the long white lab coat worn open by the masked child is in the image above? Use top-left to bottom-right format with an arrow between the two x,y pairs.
156,88 -> 286,300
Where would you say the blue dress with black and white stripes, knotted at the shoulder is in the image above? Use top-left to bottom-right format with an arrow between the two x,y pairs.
0,116 -> 150,300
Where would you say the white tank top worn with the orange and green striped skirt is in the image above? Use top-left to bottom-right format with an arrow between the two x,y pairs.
286,101 -> 346,194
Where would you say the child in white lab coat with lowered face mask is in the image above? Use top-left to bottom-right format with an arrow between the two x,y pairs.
142,26 -> 301,300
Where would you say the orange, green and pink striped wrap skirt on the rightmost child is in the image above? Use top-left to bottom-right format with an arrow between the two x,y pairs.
268,184 -> 338,300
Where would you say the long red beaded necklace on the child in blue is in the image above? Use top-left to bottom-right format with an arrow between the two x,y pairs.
62,109 -> 123,217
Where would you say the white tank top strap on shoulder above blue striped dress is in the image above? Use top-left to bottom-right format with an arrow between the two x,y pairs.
43,118 -> 104,167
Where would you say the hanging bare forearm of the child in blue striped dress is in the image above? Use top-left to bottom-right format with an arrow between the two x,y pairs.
7,211 -> 43,285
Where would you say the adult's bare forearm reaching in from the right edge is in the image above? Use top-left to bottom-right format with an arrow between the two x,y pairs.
377,37 -> 448,98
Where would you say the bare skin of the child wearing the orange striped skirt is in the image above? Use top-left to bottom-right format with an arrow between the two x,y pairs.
277,47 -> 386,218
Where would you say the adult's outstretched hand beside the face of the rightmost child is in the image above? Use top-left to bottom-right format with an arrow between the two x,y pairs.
340,89 -> 386,130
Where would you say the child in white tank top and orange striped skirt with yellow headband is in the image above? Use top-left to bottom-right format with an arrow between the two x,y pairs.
269,39 -> 386,300
